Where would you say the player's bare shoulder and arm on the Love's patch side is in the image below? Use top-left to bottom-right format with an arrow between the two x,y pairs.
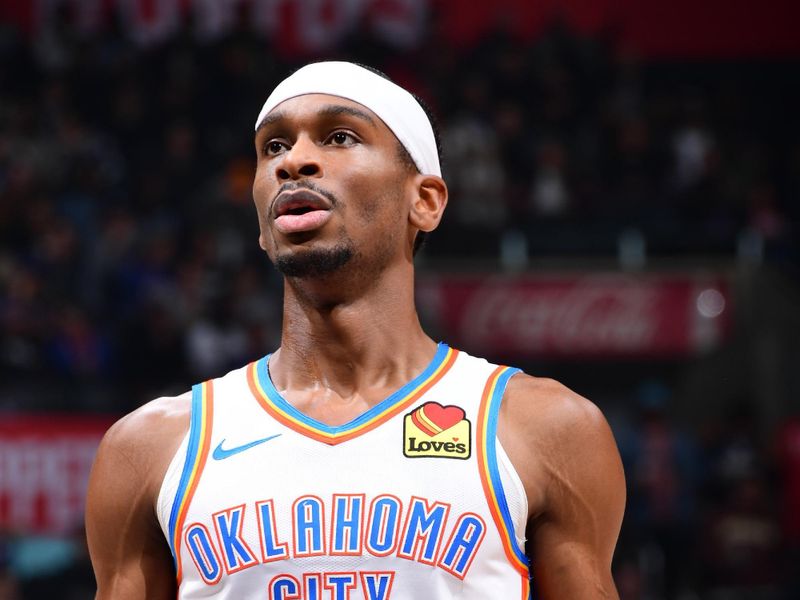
501,376 -> 625,600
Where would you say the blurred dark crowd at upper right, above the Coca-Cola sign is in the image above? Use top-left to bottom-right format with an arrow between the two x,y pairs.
433,31 -> 800,263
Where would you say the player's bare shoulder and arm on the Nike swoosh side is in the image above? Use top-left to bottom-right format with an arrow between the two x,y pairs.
86,397 -> 189,600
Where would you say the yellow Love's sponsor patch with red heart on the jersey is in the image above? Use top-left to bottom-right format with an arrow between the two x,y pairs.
403,402 -> 471,459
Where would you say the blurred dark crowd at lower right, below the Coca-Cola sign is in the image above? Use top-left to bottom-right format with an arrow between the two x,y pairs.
612,381 -> 800,600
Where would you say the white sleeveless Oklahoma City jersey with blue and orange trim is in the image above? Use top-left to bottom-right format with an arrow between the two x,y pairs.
157,344 -> 530,600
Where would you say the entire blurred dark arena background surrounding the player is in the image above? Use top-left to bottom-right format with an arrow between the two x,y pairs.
0,0 -> 800,600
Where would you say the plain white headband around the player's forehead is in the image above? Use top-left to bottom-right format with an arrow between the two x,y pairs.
256,62 -> 442,177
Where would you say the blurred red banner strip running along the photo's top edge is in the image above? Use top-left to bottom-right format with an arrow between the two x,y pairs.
0,0 -> 800,58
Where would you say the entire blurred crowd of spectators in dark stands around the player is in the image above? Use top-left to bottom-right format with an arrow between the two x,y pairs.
0,5 -> 800,599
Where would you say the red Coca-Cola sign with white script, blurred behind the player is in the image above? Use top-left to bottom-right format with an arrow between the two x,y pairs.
418,274 -> 730,356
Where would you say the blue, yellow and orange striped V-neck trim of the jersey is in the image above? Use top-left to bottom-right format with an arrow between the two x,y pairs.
247,342 -> 458,445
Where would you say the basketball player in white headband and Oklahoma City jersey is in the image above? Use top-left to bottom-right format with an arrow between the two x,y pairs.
87,62 -> 624,600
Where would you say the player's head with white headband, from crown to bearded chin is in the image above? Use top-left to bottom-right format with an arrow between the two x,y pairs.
253,62 -> 447,277
